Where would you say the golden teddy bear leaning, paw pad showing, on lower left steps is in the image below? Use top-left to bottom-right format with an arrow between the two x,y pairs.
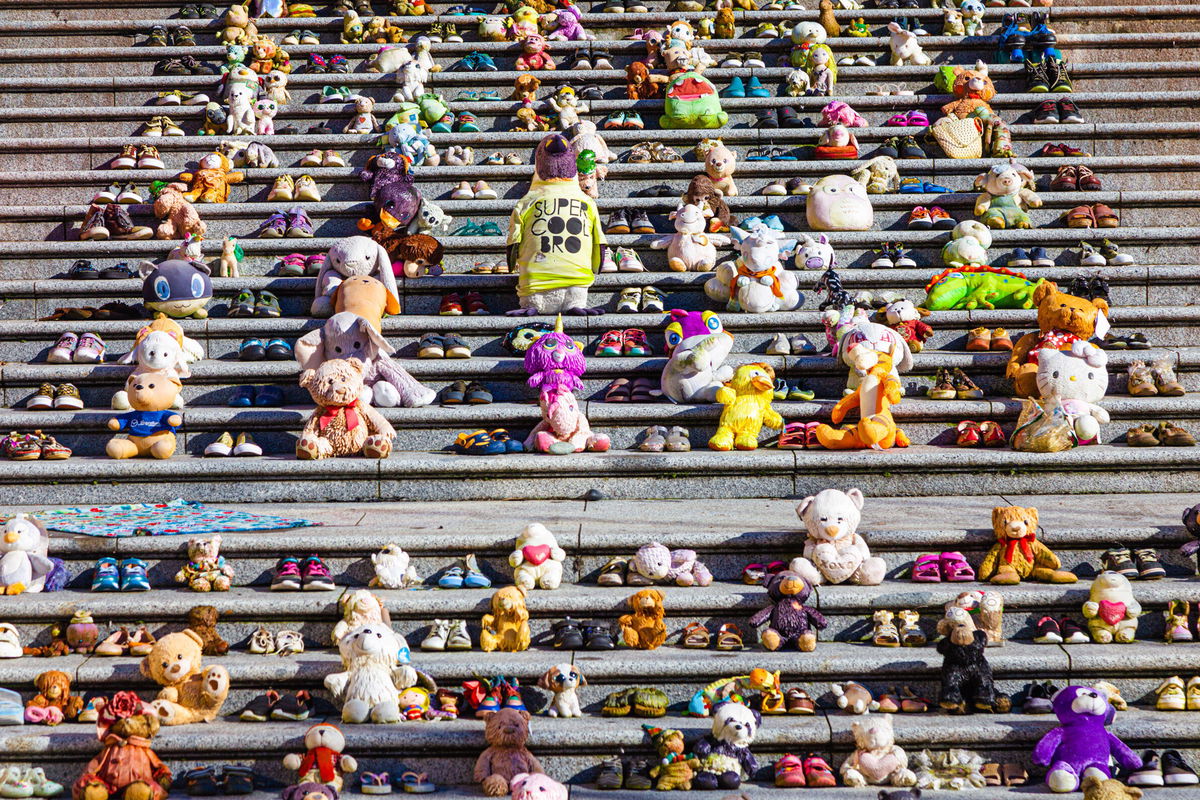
139,628 -> 229,726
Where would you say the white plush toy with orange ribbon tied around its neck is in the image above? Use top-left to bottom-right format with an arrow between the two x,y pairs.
704,226 -> 801,314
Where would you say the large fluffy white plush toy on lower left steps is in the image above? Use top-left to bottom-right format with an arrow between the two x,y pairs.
324,622 -> 420,723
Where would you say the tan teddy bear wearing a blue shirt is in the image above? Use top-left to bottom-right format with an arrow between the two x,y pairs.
104,371 -> 184,459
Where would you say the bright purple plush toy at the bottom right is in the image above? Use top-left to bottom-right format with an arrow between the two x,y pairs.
1033,686 -> 1142,792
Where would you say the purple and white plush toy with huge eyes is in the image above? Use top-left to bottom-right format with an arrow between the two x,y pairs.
660,308 -> 733,403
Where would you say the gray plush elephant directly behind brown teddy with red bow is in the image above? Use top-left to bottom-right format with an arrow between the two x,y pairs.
293,311 -> 437,408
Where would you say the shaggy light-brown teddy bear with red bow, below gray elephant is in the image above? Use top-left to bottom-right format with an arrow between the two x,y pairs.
296,359 -> 396,461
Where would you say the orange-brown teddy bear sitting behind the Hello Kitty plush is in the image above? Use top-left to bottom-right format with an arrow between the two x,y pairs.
1004,281 -> 1109,397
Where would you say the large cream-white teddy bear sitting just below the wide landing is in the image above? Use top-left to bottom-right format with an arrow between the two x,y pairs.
788,488 -> 887,587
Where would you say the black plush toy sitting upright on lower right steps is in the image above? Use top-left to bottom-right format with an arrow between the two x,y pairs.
937,606 -> 1012,714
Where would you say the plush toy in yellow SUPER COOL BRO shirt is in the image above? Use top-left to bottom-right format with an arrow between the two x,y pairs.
508,133 -> 605,315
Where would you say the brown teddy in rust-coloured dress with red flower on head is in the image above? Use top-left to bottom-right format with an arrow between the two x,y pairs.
71,691 -> 172,800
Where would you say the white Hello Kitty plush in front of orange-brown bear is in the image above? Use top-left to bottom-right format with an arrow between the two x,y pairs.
1037,341 -> 1109,445
